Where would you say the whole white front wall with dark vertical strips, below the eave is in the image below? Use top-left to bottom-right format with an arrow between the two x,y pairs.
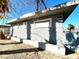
10,16 -> 63,45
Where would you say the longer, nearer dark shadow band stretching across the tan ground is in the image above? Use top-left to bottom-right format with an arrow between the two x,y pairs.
0,48 -> 44,55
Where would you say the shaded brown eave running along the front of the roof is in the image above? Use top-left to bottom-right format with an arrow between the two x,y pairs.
8,4 -> 78,24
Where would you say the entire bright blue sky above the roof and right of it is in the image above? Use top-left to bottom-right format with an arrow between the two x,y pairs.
0,0 -> 79,28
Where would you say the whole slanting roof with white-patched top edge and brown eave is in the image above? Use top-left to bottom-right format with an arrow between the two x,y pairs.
8,2 -> 79,24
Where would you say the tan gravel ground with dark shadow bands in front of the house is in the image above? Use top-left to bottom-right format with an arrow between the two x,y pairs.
0,40 -> 79,59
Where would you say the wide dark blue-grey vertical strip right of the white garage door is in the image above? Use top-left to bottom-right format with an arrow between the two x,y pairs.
49,19 -> 57,45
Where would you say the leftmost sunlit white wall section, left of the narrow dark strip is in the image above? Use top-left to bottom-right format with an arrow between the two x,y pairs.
11,23 -> 27,39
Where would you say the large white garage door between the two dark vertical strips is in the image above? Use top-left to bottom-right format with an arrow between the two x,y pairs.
31,21 -> 49,42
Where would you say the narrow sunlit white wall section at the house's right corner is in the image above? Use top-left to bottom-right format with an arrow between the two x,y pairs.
56,14 -> 65,46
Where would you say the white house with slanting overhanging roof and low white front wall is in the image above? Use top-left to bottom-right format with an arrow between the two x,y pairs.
8,2 -> 78,54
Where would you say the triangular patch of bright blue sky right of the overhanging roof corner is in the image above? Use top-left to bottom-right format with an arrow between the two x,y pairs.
64,5 -> 79,28
